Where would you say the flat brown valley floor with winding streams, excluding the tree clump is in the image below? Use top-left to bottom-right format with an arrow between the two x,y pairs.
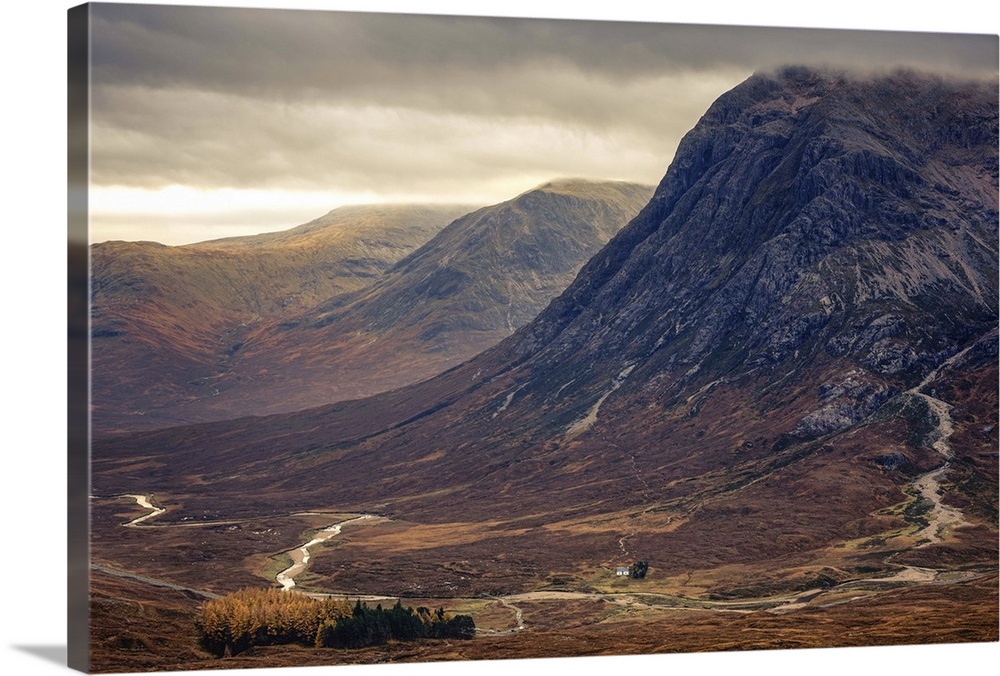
91,495 -> 1000,672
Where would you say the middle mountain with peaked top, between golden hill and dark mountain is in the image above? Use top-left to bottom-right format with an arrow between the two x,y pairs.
195,179 -> 653,419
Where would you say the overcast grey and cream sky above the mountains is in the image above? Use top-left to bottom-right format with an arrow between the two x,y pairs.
82,4 -> 997,244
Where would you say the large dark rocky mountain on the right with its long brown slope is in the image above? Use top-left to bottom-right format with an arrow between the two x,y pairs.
94,69 -> 998,594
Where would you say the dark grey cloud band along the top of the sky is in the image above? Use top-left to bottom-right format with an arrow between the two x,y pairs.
94,5 -> 996,98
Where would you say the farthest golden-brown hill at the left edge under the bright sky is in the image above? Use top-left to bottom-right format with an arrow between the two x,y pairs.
90,205 -> 471,431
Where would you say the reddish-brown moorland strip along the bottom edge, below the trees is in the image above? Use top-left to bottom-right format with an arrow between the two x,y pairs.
92,572 -> 998,672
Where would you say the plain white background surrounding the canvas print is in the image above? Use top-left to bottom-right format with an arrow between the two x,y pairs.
0,0 -> 1000,676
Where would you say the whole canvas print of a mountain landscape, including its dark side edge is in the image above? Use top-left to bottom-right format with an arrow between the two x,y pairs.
69,3 -> 998,672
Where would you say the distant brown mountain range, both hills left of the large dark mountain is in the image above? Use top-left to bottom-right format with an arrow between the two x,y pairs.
94,179 -> 652,430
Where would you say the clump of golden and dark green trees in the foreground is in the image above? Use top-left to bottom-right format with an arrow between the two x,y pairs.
195,588 -> 476,657
